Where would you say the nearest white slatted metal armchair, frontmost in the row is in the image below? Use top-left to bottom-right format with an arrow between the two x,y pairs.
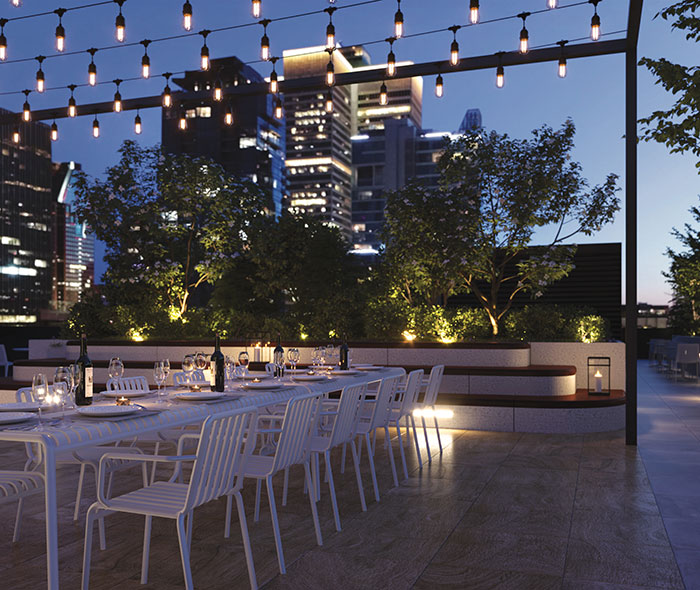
82,407 -> 257,590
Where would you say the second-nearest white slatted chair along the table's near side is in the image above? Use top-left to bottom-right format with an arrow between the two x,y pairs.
232,393 -> 323,574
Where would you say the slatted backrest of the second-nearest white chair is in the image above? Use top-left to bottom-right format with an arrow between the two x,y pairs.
272,393 -> 323,473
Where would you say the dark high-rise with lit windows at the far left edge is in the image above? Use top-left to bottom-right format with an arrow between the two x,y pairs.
0,109 -> 54,324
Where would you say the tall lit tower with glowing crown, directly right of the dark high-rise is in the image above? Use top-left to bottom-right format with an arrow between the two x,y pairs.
283,47 -> 352,241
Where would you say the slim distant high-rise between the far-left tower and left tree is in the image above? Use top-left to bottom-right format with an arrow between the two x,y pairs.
51,162 -> 95,313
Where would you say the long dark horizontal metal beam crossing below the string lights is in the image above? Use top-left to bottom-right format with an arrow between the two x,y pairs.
0,39 -> 627,125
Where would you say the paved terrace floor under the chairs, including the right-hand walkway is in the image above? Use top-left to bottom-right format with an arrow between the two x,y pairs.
0,364 -> 700,590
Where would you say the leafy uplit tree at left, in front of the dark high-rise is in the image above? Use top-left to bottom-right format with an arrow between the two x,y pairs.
76,141 -> 269,320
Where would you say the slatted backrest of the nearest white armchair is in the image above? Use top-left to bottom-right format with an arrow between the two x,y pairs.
183,407 -> 258,512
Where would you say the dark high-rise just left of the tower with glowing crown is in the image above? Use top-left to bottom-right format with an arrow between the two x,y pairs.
162,57 -> 285,214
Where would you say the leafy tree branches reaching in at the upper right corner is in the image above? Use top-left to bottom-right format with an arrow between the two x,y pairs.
640,0 -> 700,171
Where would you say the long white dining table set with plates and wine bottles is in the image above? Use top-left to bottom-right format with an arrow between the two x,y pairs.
0,367 -> 404,590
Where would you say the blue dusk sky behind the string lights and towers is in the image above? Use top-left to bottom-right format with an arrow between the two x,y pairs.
0,0 -> 700,304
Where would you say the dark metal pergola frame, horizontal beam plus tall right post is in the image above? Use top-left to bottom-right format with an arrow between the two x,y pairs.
0,0 -> 643,445
